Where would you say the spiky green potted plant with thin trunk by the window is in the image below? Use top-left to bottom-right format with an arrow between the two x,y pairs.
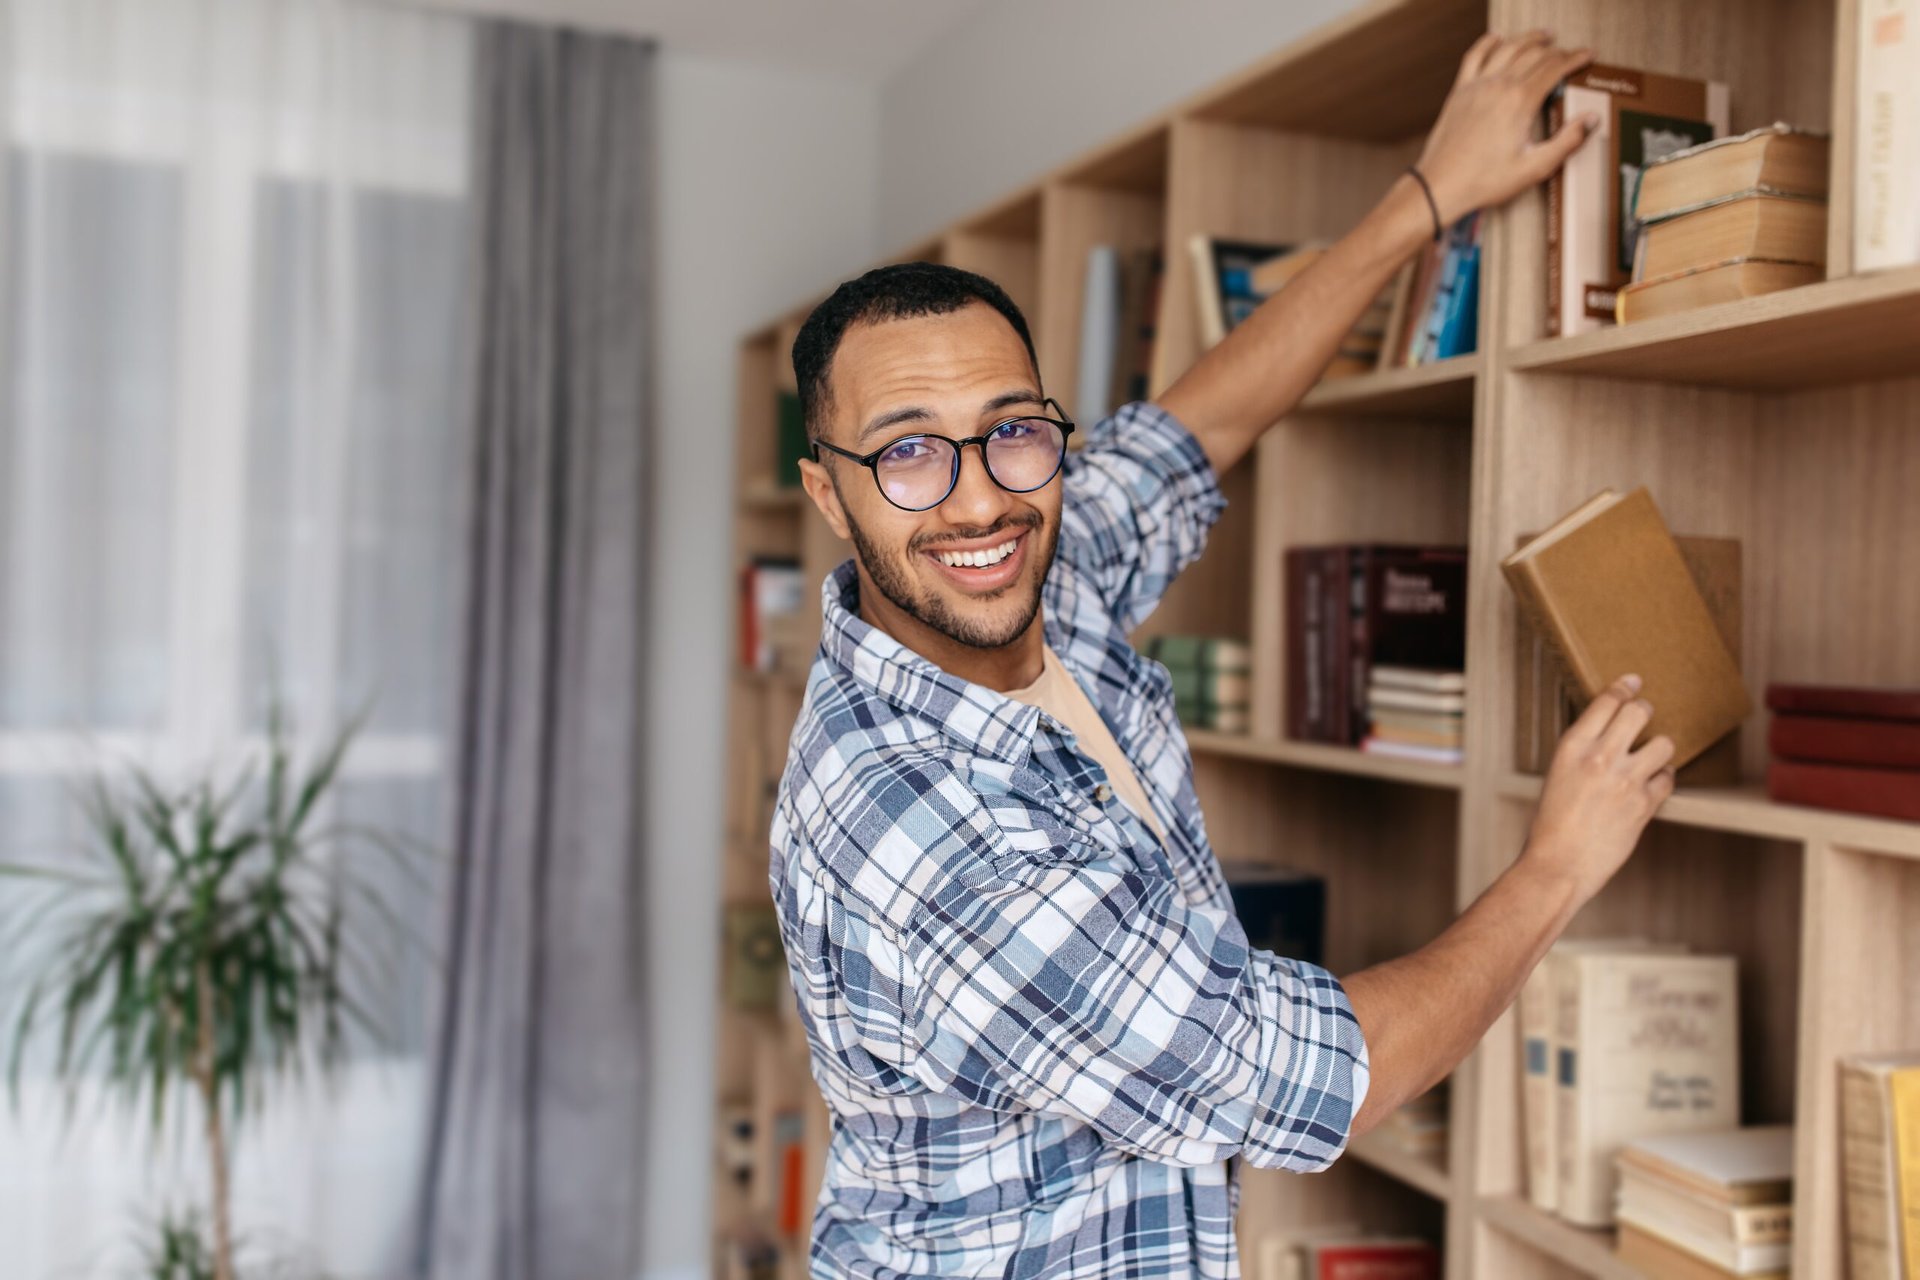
0,704 -> 422,1280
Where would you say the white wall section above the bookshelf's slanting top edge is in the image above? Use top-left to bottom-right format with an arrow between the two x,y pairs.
879,0 -> 1357,253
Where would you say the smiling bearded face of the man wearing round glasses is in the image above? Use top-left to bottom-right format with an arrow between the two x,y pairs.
803,303 -> 1060,649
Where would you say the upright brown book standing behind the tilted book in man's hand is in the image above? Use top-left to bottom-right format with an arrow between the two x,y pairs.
1513,533 -> 1743,787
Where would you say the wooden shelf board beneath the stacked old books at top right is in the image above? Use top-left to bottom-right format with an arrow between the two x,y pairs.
1509,267 -> 1920,390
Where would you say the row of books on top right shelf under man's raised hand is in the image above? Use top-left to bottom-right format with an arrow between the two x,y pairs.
1548,26 -> 1920,334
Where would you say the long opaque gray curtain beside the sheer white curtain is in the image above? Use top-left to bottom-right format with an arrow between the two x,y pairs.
415,23 -> 653,1280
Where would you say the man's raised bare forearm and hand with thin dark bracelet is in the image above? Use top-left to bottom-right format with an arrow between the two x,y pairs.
1160,31 -> 1596,474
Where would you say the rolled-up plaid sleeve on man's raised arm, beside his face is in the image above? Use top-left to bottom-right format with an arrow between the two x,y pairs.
1060,401 -> 1227,628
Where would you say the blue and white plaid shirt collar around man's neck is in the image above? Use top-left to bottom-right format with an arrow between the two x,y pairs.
820,560 -> 1050,768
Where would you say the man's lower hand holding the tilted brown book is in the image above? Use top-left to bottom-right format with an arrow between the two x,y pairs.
1523,676 -> 1674,902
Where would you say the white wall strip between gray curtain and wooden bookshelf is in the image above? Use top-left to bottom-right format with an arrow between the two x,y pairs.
643,48 -> 879,1280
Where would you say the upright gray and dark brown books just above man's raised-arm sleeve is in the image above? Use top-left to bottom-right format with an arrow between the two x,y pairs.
1073,244 -> 1165,422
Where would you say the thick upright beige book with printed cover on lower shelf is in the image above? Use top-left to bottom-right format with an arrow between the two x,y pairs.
1553,952 -> 1740,1226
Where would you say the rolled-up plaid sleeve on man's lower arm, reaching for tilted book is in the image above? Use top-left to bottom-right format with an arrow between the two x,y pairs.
904,844 -> 1369,1173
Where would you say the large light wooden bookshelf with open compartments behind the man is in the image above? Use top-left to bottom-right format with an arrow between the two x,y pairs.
714,0 -> 1920,1280
